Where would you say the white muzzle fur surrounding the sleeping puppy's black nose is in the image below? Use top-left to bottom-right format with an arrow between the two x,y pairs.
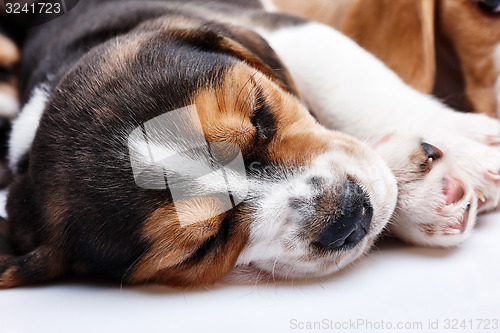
236,147 -> 397,278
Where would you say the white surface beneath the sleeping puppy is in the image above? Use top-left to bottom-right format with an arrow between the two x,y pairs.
0,189 -> 500,333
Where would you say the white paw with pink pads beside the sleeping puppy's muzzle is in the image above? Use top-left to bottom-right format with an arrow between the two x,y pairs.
375,113 -> 500,247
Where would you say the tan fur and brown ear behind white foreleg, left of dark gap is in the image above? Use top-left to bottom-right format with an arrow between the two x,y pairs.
273,0 -> 435,93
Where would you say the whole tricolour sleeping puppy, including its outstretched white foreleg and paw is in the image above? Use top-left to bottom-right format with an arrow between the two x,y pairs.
0,0 -> 500,288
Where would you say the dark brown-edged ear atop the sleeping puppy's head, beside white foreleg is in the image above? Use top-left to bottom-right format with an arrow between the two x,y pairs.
171,24 -> 298,96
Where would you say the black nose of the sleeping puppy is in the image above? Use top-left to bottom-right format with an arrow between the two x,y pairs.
316,181 -> 373,251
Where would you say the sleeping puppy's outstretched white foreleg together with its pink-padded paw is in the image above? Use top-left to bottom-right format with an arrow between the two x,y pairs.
258,23 -> 500,246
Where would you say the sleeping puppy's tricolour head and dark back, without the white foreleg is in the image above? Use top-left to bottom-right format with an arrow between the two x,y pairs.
0,1 -> 397,288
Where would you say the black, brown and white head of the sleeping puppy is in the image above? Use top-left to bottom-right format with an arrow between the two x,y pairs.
31,22 -> 397,286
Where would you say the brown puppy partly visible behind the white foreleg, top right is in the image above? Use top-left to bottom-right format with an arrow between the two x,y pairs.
270,0 -> 500,117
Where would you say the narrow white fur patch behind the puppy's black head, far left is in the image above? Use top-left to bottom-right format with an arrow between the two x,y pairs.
9,85 -> 49,170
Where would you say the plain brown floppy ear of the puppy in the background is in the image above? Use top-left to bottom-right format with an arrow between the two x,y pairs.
342,0 -> 436,93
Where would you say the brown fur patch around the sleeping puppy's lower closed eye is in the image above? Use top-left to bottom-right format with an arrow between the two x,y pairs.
131,197 -> 248,286
